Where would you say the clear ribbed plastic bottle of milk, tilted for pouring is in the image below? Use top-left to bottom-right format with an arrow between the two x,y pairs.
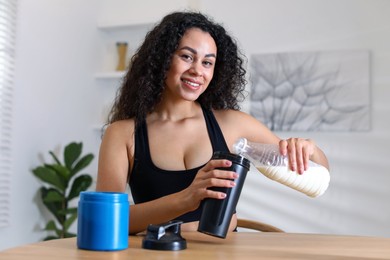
233,138 -> 330,197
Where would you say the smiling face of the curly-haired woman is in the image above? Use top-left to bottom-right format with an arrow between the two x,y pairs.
165,28 -> 217,101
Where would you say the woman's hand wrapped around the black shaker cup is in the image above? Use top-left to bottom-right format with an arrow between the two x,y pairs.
182,159 -> 238,211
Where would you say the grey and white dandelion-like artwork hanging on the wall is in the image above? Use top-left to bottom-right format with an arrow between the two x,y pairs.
250,51 -> 370,131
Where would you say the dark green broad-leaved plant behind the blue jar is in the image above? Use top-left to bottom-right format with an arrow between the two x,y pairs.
32,142 -> 94,240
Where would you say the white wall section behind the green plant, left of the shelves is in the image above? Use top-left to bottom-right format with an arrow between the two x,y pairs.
0,0 -> 98,248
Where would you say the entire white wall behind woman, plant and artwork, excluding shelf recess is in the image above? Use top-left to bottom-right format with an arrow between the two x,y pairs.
0,0 -> 390,249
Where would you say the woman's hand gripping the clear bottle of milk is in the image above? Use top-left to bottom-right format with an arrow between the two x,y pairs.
279,138 -> 316,174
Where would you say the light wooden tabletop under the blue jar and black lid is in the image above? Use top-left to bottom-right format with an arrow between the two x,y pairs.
0,232 -> 390,260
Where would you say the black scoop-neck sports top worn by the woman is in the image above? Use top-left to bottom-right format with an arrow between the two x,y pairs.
129,107 -> 229,222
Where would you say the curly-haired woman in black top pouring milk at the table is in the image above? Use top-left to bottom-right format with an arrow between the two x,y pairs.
97,12 -> 328,234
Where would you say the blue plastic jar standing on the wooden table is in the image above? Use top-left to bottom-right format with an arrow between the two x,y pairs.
77,191 -> 129,251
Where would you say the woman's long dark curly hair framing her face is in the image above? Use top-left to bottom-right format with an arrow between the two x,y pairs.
108,12 -> 246,126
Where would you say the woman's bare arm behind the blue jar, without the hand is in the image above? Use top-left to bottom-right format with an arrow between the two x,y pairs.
96,121 -> 189,234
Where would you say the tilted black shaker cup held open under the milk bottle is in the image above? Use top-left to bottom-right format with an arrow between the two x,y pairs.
198,152 -> 250,238
